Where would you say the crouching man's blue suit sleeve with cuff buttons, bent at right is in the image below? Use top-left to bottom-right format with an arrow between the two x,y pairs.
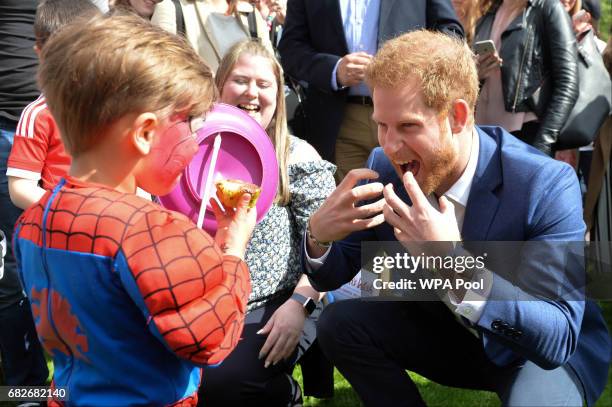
478,161 -> 585,369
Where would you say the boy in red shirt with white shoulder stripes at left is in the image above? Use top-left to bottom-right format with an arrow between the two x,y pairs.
6,0 -> 98,209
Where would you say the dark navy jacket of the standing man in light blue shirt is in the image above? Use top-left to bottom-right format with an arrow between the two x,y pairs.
278,0 -> 463,161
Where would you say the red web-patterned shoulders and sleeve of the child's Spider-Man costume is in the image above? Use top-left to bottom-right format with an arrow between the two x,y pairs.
18,182 -> 251,364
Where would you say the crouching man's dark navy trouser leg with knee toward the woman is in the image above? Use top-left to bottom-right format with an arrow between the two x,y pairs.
317,300 -> 503,406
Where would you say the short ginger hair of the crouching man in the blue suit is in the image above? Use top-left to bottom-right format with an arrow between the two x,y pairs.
366,30 -> 478,116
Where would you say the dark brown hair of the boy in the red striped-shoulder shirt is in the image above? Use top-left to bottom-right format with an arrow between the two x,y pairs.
34,0 -> 100,49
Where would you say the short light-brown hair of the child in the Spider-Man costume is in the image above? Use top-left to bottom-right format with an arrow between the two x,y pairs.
38,15 -> 217,157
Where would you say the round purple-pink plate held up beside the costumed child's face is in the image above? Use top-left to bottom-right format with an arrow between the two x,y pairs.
159,103 -> 278,235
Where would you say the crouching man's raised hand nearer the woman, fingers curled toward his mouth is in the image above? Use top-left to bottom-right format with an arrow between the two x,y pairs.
309,168 -> 385,252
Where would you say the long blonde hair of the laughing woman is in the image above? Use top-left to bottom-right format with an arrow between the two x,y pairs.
215,40 -> 291,205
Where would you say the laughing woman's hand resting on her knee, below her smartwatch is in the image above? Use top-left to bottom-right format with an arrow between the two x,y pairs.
257,299 -> 306,367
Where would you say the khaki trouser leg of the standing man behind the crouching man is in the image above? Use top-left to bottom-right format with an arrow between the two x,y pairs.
335,103 -> 378,183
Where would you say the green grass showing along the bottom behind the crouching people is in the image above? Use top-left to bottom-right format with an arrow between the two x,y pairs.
294,302 -> 612,407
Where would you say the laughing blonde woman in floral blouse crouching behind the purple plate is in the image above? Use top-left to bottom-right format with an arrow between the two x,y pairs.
200,40 -> 335,406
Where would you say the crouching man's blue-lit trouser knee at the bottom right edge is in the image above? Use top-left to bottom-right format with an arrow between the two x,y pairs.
500,361 -> 583,407
